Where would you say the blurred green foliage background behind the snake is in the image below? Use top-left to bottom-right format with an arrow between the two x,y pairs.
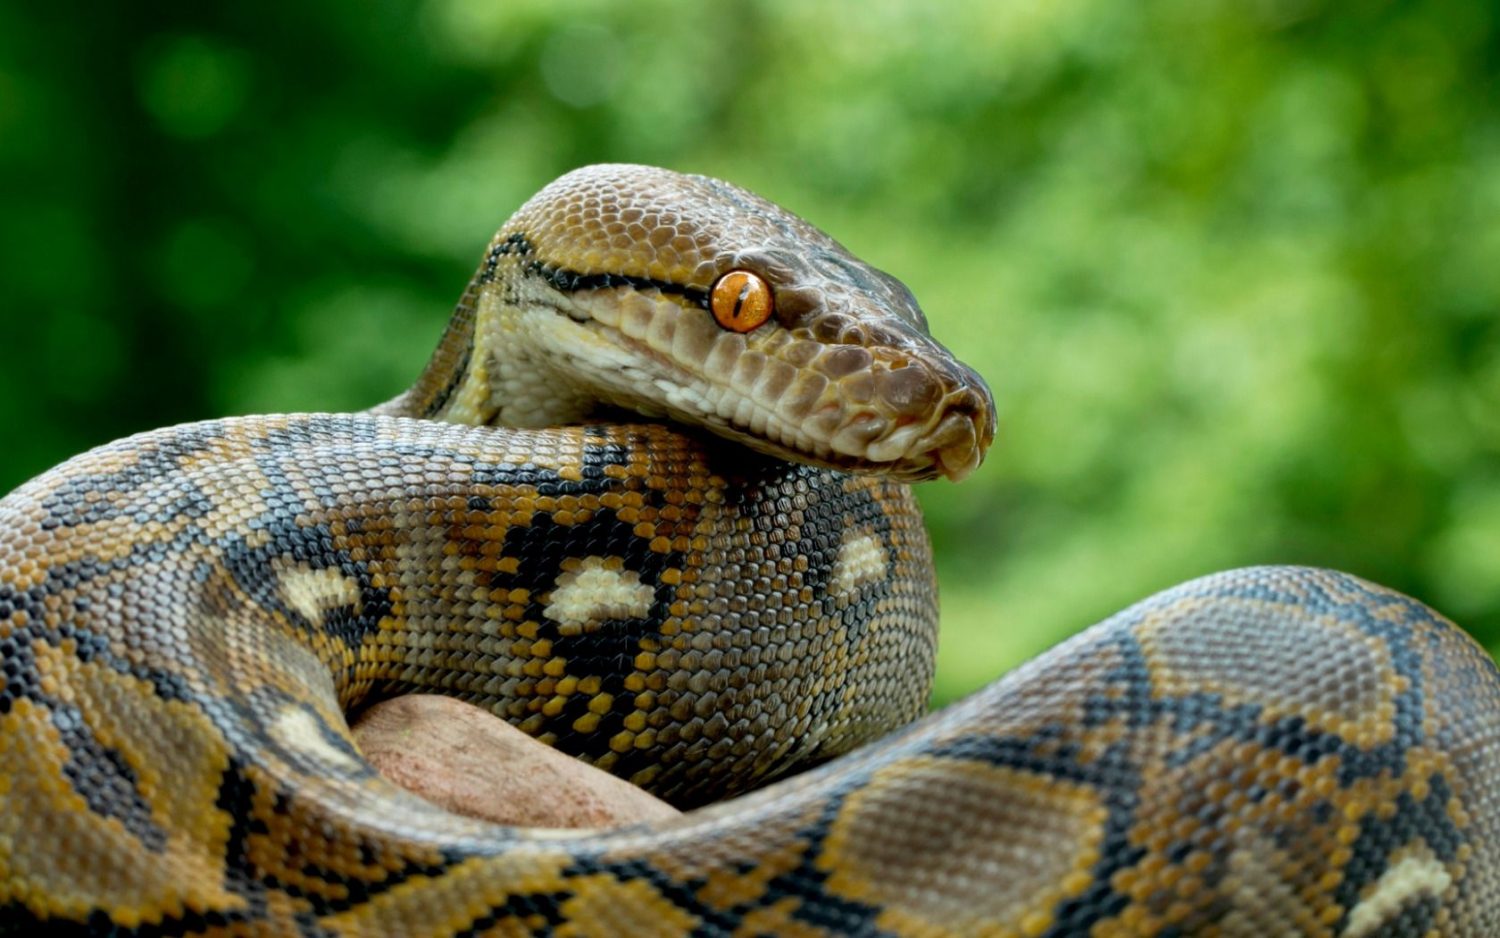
0,0 -> 1500,701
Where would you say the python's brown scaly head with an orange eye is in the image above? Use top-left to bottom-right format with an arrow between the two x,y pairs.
441,165 -> 995,480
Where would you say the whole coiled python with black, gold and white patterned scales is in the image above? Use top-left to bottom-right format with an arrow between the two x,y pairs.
0,165 -> 1500,938
